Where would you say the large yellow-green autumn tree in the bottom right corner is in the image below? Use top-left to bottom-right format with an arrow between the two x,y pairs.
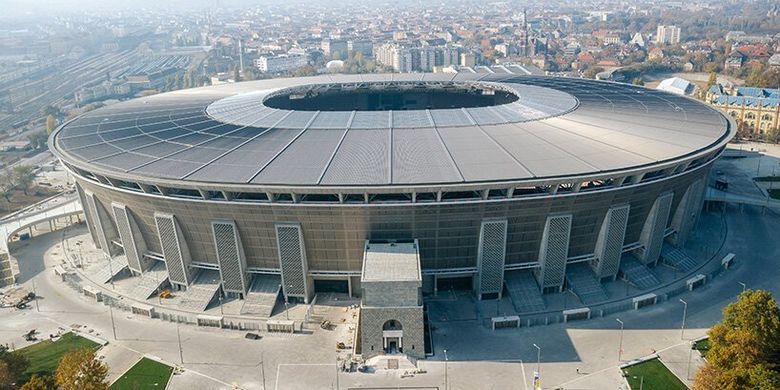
693,290 -> 780,390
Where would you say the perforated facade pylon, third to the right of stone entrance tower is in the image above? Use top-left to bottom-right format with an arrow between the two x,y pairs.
593,205 -> 630,278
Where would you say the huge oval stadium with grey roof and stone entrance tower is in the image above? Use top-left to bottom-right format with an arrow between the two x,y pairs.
49,72 -> 735,356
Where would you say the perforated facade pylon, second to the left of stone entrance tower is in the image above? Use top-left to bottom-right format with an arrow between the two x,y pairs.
211,221 -> 247,294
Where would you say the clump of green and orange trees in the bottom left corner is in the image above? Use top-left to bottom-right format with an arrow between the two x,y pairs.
0,345 -> 108,390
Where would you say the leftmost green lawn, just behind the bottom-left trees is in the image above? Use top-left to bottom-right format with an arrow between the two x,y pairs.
18,333 -> 100,376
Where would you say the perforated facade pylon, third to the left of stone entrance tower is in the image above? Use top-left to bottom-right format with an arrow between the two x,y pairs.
154,213 -> 192,286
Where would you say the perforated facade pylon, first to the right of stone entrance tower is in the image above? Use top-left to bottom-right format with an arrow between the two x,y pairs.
476,220 -> 507,295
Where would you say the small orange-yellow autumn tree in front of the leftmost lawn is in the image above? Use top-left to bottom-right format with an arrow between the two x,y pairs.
54,349 -> 108,390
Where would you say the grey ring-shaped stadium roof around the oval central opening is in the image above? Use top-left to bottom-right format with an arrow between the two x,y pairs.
52,73 -> 730,186
